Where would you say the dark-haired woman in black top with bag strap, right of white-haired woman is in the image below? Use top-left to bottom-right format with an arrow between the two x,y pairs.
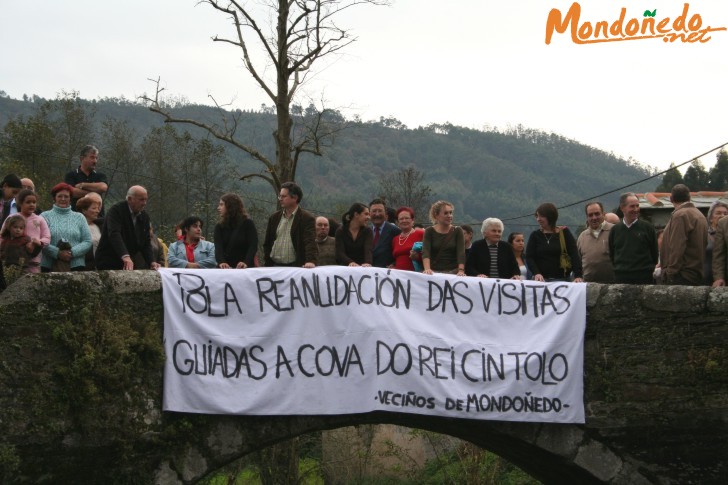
526,202 -> 584,283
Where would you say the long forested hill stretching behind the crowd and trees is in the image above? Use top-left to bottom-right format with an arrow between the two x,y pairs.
0,92 -> 655,231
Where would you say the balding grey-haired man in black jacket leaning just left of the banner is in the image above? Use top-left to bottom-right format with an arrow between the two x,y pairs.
95,185 -> 159,270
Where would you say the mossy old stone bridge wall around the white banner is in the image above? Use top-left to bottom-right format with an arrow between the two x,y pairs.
0,271 -> 728,484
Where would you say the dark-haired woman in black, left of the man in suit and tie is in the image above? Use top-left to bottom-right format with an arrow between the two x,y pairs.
336,202 -> 374,266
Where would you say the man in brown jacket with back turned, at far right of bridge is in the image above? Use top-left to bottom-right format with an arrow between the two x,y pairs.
660,184 -> 708,286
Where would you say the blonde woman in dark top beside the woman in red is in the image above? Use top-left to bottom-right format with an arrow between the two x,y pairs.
422,200 -> 465,276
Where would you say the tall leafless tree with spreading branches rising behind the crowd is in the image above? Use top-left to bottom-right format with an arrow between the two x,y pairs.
142,0 -> 389,194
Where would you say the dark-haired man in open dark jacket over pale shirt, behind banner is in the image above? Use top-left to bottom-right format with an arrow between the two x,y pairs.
263,182 -> 318,268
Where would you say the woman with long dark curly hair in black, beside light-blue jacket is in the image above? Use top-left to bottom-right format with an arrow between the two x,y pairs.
215,194 -> 258,269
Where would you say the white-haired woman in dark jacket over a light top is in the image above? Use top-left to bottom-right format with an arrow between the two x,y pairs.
465,217 -> 521,280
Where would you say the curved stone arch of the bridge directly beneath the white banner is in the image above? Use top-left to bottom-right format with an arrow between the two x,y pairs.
155,412 -> 652,484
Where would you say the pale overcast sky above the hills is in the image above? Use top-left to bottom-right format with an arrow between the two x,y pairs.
0,0 -> 728,172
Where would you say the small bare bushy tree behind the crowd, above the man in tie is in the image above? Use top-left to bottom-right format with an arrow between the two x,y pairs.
379,165 -> 433,221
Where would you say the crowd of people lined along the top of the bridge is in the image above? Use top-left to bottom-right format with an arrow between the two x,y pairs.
0,145 -> 728,286
